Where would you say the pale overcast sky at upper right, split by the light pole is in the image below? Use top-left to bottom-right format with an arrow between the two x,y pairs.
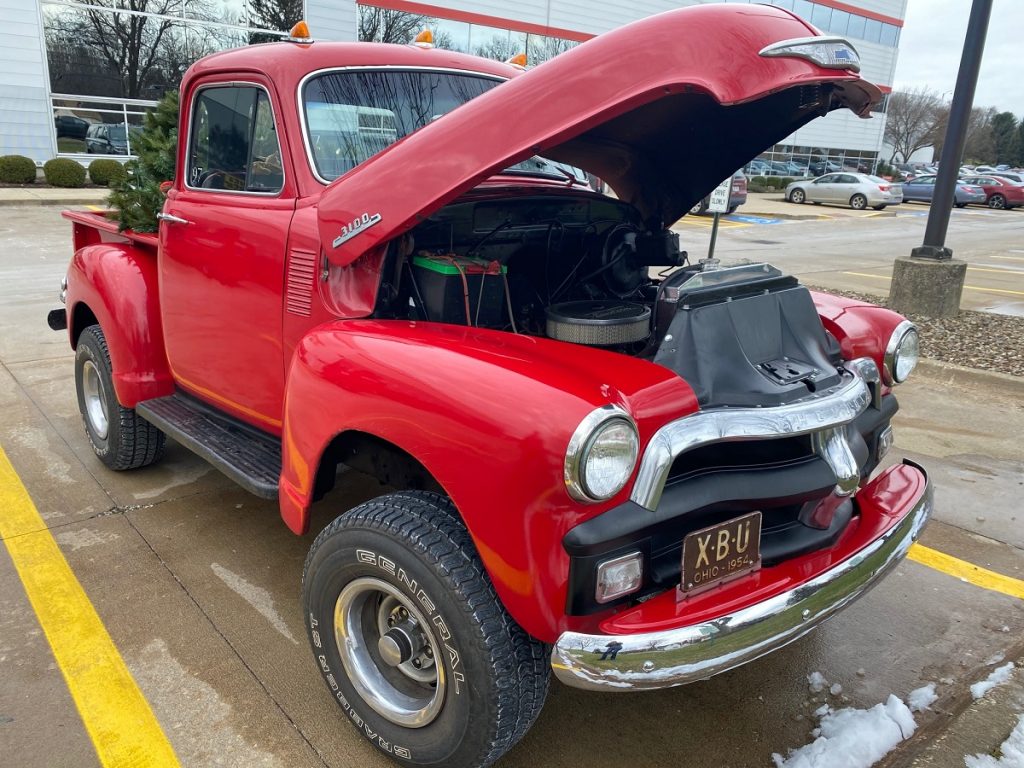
894,0 -> 1024,119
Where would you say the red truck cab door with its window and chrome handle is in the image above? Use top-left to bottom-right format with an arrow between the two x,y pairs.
160,81 -> 295,433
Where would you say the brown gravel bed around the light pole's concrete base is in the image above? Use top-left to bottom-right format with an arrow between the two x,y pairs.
813,288 -> 1024,376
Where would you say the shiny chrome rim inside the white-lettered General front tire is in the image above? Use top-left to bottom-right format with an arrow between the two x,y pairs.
334,577 -> 445,728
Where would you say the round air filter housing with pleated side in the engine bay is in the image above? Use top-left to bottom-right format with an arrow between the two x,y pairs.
547,300 -> 650,347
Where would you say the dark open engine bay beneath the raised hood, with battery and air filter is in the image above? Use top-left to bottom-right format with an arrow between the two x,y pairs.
378,190 -> 686,353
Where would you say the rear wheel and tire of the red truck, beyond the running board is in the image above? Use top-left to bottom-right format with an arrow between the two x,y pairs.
75,326 -> 166,471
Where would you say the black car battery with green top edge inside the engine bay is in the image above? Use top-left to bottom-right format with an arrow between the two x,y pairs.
413,251 -> 509,328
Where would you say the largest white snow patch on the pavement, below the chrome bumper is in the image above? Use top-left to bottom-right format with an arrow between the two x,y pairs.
772,696 -> 917,768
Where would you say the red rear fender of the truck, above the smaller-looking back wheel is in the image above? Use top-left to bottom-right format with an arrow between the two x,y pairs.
68,243 -> 174,408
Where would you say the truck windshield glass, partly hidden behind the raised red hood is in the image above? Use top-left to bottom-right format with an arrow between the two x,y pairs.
302,70 -> 587,182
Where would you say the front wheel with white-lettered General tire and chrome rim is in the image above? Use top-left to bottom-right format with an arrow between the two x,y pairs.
302,492 -> 550,768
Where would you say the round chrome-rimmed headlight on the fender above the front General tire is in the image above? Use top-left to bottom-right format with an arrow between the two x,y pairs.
565,406 -> 640,502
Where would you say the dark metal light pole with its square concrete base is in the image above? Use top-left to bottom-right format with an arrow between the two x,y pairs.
889,0 -> 992,317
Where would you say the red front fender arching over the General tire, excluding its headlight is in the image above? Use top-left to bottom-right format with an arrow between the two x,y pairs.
281,319 -> 697,642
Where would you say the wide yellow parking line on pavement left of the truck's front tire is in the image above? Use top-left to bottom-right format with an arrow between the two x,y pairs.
0,447 -> 178,768
